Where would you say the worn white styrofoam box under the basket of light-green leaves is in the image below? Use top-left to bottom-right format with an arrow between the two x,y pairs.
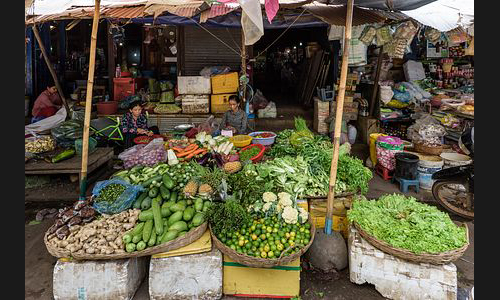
348,227 -> 457,300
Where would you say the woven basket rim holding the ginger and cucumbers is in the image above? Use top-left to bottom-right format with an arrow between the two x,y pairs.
43,222 -> 208,260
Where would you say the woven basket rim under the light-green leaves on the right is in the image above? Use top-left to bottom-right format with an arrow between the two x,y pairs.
353,222 -> 469,265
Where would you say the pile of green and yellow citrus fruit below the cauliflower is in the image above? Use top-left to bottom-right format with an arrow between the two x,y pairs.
216,216 -> 311,259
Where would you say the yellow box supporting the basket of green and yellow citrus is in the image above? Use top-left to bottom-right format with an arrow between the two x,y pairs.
222,255 -> 301,298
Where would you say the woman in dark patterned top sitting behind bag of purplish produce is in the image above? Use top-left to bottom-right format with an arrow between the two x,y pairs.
120,101 -> 160,148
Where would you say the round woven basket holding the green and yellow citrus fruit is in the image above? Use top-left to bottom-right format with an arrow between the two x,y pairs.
210,218 -> 316,268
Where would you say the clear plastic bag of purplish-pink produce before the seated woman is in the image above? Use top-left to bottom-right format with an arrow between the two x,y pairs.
118,138 -> 167,169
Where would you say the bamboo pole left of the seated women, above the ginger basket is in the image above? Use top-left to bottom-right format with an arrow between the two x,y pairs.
80,0 -> 101,200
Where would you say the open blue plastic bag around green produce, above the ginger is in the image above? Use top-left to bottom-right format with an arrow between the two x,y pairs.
92,179 -> 144,215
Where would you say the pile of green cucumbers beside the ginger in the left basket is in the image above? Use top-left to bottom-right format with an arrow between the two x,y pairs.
123,174 -> 212,252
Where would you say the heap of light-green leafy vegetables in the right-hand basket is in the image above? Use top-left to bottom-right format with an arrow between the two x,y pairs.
347,194 -> 467,254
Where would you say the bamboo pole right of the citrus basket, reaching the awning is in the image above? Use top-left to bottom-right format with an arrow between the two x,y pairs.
325,0 -> 354,235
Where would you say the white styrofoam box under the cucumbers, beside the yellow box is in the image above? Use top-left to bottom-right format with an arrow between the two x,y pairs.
149,247 -> 222,300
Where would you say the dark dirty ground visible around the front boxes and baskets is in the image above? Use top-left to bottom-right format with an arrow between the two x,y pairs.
25,146 -> 474,300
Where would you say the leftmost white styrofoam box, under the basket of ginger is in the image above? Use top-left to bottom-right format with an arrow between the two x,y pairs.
53,257 -> 147,300
